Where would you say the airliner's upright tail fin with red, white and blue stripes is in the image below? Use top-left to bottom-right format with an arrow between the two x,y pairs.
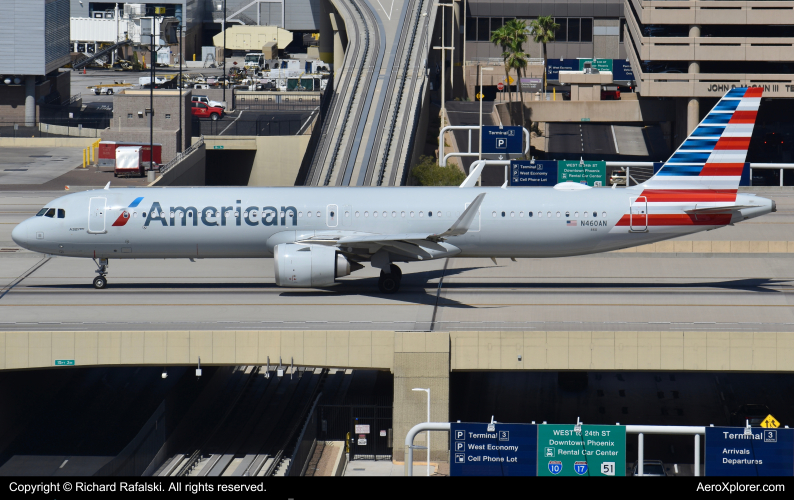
641,87 -> 763,202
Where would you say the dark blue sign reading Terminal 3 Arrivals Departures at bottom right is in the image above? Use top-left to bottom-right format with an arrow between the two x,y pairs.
705,427 -> 794,476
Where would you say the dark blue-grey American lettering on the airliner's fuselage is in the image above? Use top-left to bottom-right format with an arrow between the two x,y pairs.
143,200 -> 298,227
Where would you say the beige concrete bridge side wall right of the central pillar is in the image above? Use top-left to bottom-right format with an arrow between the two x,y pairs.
448,331 -> 794,374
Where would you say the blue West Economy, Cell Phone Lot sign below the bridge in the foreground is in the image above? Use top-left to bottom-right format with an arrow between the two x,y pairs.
449,423 -> 538,476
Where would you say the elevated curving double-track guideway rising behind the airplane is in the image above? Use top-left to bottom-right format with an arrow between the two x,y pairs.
307,0 -> 436,186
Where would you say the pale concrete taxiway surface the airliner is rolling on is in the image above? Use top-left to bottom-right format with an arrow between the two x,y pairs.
0,190 -> 794,332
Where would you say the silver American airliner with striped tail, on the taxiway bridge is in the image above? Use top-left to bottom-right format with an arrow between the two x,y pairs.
12,88 -> 775,294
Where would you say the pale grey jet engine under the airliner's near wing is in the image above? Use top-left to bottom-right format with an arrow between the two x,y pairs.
273,243 -> 354,287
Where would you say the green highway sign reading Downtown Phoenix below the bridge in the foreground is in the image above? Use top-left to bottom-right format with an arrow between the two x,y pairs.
538,424 -> 626,476
